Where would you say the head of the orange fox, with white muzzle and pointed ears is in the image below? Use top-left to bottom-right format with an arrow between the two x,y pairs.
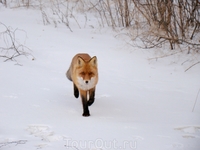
76,56 -> 98,90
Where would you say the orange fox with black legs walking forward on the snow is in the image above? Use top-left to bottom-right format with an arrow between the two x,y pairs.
66,53 -> 98,117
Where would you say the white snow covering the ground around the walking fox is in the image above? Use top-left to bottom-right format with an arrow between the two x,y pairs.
0,3 -> 200,150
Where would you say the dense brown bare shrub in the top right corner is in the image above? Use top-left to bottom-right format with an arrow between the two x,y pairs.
133,0 -> 200,50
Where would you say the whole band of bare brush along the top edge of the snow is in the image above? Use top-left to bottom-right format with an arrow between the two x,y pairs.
1,0 -> 200,53
